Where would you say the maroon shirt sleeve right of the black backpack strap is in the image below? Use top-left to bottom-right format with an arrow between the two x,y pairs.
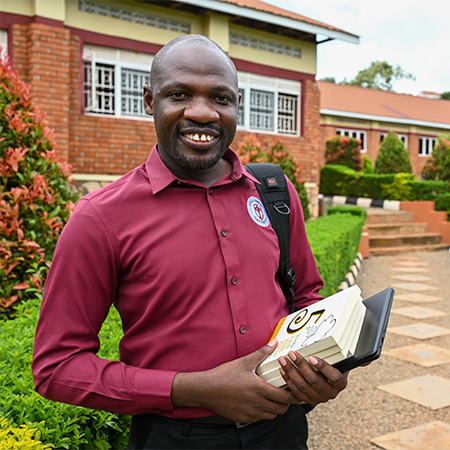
287,179 -> 323,309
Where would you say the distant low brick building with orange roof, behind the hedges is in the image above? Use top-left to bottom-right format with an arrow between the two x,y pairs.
317,81 -> 450,177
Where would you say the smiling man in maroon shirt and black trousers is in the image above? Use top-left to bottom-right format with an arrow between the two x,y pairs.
33,35 -> 347,449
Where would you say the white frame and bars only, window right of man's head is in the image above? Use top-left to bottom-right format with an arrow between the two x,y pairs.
237,72 -> 301,137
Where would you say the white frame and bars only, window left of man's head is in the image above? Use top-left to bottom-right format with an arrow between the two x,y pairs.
83,45 -> 153,120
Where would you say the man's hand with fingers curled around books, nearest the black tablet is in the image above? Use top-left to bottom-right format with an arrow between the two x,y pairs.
278,352 -> 348,405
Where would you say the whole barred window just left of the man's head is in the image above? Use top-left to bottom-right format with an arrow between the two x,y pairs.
83,46 -> 153,117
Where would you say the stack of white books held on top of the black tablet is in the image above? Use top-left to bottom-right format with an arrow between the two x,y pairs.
256,285 -> 366,387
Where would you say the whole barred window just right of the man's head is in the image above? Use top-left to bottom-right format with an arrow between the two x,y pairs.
238,72 -> 301,135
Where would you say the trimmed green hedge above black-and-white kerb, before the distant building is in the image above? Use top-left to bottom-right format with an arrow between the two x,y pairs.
320,165 -> 450,200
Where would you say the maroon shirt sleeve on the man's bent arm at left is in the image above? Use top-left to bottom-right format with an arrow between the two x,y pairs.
32,199 -> 176,415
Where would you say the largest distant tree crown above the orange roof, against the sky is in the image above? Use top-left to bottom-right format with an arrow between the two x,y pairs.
340,61 -> 416,91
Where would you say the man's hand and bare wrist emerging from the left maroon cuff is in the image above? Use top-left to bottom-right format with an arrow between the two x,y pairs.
171,341 -> 301,423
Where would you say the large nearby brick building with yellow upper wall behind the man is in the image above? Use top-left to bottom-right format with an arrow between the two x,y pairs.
0,0 -> 358,208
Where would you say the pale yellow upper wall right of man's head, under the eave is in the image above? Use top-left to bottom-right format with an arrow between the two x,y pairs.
229,25 -> 317,75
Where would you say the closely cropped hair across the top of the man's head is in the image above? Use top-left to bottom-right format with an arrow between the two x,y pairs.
150,34 -> 238,89
